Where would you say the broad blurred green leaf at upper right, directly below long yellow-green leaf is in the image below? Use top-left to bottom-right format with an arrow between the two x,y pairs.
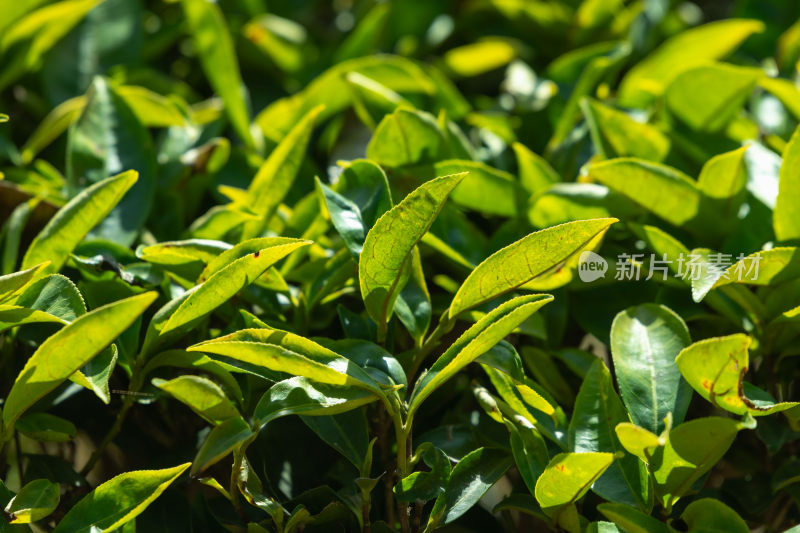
664,63 -> 764,132
